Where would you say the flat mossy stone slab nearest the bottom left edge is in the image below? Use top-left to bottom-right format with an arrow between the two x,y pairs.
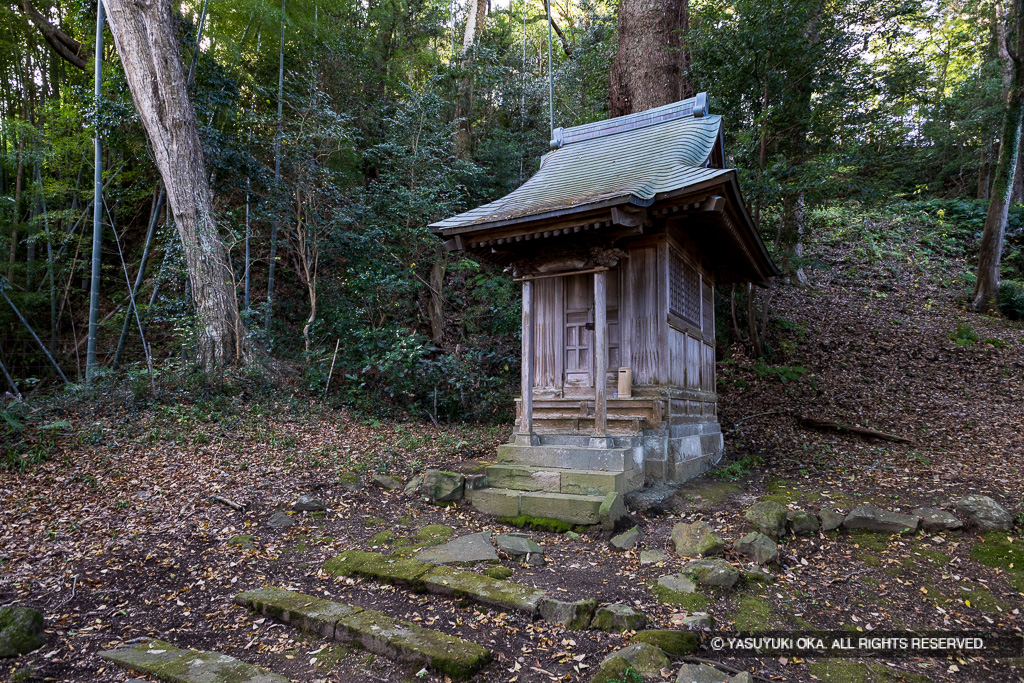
99,640 -> 288,683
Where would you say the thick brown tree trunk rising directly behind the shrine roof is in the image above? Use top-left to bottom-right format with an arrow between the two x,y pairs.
610,0 -> 693,117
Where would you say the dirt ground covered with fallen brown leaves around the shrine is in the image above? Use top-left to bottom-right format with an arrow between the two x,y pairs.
0,209 -> 1024,683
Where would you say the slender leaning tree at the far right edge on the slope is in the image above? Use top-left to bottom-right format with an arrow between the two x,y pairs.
973,0 -> 1024,312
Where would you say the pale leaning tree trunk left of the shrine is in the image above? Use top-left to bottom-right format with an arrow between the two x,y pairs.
106,0 -> 248,369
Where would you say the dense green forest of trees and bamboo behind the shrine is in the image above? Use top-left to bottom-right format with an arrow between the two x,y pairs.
0,0 -> 1024,421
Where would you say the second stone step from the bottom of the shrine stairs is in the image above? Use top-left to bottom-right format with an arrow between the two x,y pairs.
486,465 -> 643,496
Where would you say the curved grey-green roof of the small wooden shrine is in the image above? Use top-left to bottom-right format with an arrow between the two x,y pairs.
430,105 -> 732,230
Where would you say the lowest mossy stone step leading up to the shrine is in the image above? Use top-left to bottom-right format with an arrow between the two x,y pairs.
472,488 -> 626,527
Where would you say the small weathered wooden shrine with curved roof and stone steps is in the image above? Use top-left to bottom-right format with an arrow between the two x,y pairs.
431,93 -> 779,524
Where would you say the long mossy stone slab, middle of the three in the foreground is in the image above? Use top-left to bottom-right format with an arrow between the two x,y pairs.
234,588 -> 490,680
